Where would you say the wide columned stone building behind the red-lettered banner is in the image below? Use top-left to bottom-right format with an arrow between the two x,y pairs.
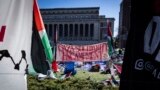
40,7 -> 115,45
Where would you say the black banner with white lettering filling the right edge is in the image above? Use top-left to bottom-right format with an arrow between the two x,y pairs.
119,0 -> 160,90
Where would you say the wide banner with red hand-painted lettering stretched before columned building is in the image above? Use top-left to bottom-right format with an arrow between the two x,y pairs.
57,43 -> 109,61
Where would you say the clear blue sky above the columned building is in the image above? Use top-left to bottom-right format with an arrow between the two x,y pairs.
38,0 -> 121,36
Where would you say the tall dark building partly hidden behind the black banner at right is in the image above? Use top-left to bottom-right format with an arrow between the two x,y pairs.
118,0 -> 131,48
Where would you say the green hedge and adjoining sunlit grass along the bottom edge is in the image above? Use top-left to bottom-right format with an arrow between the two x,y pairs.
28,69 -> 118,90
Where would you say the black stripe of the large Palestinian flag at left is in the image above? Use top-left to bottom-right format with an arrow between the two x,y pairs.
31,16 -> 50,75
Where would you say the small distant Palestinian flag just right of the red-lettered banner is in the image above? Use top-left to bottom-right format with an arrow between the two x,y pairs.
107,20 -> 114,56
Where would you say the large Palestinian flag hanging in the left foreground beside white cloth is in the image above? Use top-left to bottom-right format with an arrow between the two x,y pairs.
31,0 -> 53,74
